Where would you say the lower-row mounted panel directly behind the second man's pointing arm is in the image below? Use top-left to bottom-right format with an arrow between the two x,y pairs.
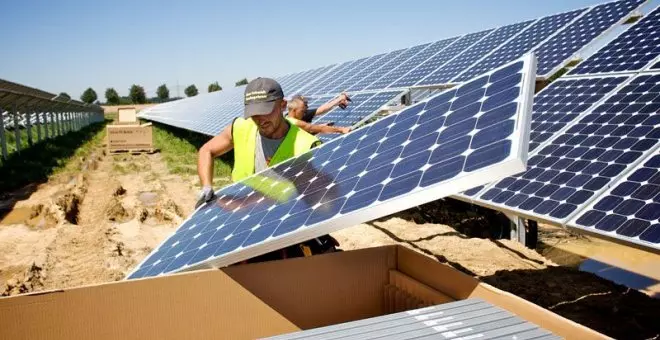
314,91 -> 401,126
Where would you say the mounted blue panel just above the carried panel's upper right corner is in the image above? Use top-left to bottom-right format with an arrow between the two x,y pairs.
536,0 -> 646,77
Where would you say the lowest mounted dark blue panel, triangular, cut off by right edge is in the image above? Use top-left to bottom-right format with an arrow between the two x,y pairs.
569,151 -> 660,251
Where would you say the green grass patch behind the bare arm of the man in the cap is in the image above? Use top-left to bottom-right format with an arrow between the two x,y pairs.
153,123 -> 233,187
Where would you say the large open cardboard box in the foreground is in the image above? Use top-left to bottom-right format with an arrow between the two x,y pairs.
0,246 -> 606,340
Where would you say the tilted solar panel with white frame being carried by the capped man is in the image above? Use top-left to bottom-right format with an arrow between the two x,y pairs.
127,54 -> 536,279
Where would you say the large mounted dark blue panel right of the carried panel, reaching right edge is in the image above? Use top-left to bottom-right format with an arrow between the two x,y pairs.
477,75 -> 660,224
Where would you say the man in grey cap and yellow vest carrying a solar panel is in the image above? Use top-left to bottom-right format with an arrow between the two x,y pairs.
195,78 -> 338,262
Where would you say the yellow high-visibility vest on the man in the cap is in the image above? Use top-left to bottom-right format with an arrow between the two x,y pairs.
231,117 -> 319,182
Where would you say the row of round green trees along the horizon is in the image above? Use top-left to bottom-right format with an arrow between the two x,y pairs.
69,78 -> 248,105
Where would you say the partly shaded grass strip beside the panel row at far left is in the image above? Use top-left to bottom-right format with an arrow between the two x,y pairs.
0,121 -> 107,192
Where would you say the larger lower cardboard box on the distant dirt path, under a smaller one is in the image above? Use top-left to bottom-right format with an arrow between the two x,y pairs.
107,123 -> 153,152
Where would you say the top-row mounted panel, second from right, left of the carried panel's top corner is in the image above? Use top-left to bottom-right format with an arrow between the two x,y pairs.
452,9 -> 586,82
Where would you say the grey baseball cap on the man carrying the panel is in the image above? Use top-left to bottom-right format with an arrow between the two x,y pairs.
244,77 -> 284,119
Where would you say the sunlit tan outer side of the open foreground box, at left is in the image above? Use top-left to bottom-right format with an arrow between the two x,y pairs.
0,270 -> 298,340
